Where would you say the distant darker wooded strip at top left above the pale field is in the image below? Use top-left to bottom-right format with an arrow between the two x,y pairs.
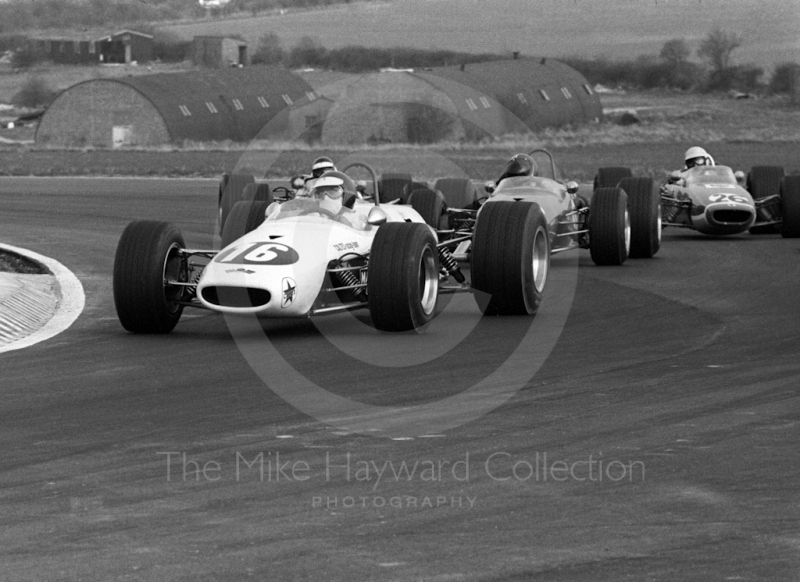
0,0 -> 356,34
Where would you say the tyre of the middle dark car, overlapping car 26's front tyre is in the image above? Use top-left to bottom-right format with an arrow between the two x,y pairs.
589,188 -> 631,266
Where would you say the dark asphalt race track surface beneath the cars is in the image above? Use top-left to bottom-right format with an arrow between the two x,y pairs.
0,178 -> 800,581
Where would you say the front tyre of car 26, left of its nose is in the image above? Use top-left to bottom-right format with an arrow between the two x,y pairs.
619,178 -> 661,259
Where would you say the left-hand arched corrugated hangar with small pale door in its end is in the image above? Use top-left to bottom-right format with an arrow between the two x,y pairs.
36,66 -> 331,147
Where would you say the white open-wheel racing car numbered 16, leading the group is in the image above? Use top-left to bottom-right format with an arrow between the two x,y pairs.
113,162 -> 550,333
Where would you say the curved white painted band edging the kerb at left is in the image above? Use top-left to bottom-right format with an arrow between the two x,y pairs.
0,243 -> 86,353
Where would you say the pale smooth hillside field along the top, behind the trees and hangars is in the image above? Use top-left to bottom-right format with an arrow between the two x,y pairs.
163,0 -> 800,71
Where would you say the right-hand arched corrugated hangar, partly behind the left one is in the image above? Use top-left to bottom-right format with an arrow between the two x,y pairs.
317,58 -> 603,144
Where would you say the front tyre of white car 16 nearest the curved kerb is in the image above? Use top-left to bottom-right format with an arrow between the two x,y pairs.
113,220 -> 187,333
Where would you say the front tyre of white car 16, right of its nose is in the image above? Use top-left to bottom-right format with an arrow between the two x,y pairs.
367,222 -> 439,332
